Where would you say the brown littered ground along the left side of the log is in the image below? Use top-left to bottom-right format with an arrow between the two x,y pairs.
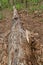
0,9 -> 12,65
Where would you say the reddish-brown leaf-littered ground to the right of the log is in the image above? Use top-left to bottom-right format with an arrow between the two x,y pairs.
19,11 -> 43,43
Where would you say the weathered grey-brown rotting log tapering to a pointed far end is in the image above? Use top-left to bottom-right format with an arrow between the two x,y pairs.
8,6 -> 42,65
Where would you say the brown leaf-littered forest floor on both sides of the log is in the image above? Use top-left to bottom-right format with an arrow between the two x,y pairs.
0,10 -> 43,65
